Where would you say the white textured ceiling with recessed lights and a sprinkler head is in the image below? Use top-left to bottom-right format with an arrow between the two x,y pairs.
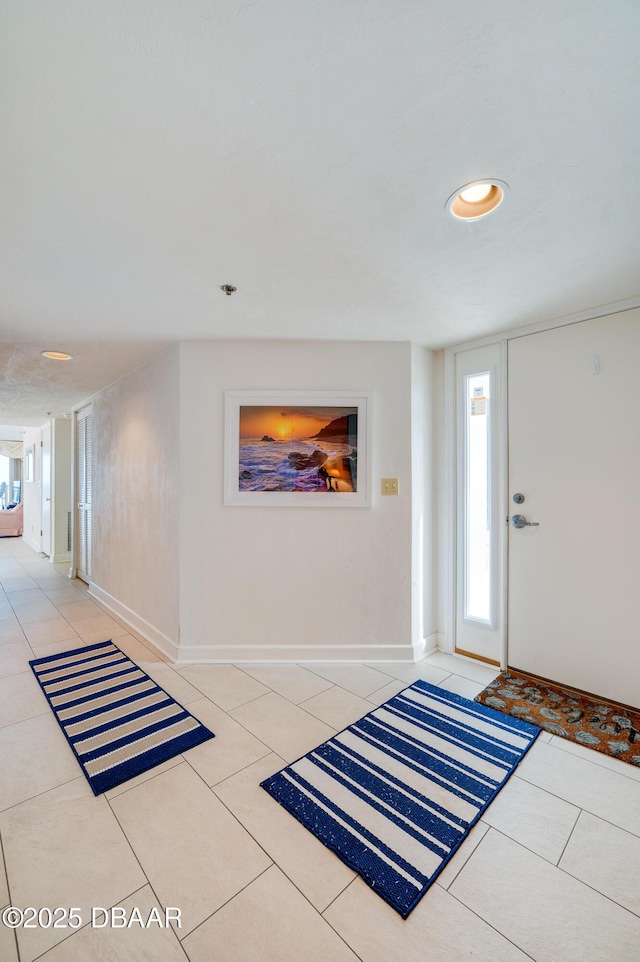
0,0 -> 640,423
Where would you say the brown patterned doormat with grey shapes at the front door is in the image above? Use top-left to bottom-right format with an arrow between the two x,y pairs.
475,669 -> 640,766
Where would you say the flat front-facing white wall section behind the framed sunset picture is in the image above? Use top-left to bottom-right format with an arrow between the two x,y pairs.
179,341 -> 420,661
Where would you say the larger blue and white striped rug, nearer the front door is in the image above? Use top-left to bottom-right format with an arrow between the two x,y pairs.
262,681 -> 540,918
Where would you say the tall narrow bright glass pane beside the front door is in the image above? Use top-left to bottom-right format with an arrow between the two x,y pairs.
464,372 -> 492,624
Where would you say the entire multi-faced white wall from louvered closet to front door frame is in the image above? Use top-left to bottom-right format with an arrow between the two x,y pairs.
85,341 -> 437,662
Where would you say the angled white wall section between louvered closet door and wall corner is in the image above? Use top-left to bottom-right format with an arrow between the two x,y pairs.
91,347 -> 180,657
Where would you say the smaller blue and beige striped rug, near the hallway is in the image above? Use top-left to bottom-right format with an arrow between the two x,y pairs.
29,641 -> 214,795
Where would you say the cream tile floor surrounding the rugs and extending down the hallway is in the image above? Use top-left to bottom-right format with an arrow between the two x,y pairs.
0,539 -> 640,962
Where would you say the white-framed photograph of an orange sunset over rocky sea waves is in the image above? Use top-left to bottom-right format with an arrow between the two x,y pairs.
224,391 -> 370,508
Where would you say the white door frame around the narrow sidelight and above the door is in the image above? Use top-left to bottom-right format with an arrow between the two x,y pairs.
439,297 -> 640,669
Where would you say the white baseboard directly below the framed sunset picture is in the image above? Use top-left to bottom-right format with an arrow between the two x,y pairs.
177,644 -> 416,665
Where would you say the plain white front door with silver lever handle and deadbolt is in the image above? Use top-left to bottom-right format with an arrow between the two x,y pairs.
507,310 -> 640,706
